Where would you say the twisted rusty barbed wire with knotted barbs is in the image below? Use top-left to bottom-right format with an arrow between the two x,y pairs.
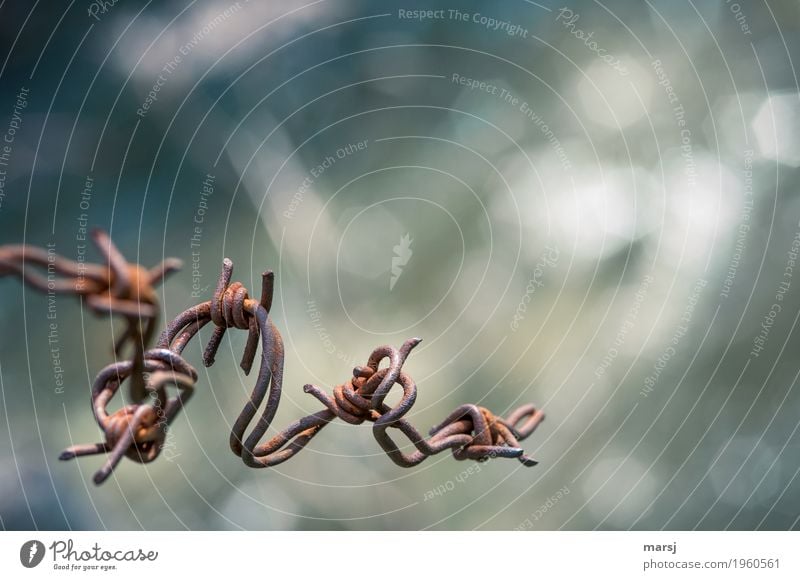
0,230 -> 544,484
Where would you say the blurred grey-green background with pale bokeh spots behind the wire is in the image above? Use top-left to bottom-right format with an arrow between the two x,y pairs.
0,0 -> 800,530
